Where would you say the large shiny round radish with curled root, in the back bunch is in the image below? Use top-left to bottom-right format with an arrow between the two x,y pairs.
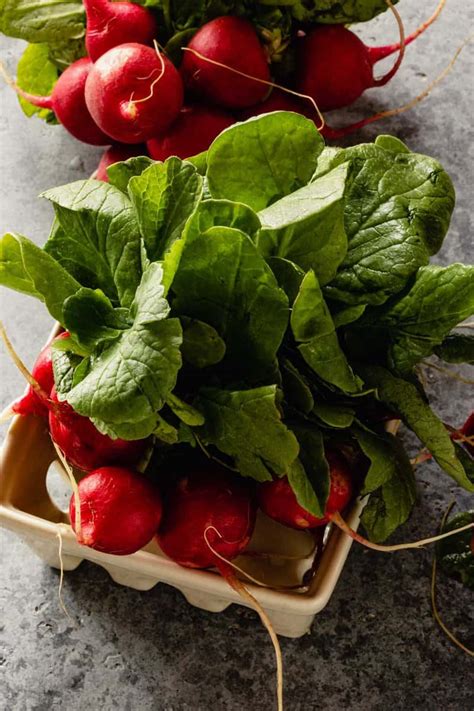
85,42 -> 183,143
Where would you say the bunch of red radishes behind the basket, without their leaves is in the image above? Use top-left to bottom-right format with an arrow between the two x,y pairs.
4,0 -> 445,168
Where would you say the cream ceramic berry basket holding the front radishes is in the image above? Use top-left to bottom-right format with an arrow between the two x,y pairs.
0,329 -> 394,637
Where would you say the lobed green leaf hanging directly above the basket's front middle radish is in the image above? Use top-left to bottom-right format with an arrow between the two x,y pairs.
195,385 -> 299,481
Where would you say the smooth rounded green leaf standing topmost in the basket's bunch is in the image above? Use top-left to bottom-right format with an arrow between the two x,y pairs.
207,111 -> 324,212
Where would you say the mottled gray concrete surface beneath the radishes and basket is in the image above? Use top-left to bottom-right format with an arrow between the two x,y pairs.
0,0 -> 474,711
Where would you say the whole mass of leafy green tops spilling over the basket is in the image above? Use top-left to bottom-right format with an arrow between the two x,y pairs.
0,112 -> 474,540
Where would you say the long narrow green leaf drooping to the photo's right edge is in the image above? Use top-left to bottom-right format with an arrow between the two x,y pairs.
357,365 -> 474,491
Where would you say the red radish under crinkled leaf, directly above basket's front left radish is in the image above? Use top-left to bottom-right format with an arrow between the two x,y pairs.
49,388 -> 148,471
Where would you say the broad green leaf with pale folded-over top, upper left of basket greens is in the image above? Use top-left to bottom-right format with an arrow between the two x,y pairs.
43,180 -> 142,307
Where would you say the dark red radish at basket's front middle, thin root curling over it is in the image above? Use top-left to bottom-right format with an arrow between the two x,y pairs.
158,464 -> 256,568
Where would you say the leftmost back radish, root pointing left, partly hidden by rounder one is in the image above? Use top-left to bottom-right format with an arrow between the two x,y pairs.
9,57 -> 110,146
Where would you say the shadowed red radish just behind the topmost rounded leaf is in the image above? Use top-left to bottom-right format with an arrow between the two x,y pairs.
147,105 -> 235,160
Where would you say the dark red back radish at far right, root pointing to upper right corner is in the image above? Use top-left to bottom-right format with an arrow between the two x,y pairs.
296,0 -> 445,111
